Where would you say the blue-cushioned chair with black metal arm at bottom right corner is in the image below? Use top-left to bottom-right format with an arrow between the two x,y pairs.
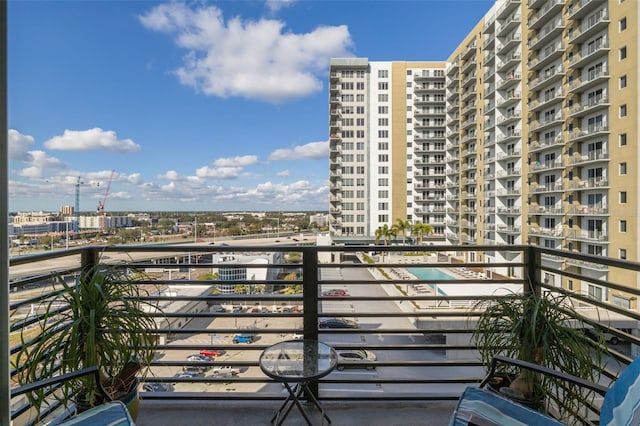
449,356 -> 640,426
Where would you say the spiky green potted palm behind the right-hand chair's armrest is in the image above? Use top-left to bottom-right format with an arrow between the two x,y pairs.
472,286 -> 607,423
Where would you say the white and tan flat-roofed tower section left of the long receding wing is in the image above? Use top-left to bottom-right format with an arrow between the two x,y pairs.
329,59 -> 446,236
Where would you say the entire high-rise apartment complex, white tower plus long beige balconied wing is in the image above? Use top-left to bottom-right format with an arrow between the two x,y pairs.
329,0 -> 640,308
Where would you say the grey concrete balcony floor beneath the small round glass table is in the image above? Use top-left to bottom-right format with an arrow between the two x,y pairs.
136,400 -> 455,426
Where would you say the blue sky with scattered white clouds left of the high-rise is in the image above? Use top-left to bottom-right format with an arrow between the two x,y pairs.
8,0 -> 493,212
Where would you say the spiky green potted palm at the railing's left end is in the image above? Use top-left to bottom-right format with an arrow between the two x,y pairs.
14,264 -> 158,417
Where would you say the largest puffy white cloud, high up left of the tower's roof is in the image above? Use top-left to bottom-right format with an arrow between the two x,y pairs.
140,3 -> 353,102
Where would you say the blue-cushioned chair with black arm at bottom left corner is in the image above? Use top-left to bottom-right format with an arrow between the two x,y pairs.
11,367 -> 135,426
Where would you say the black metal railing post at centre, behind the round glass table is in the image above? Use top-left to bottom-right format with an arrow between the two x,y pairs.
302,246 -> 319,399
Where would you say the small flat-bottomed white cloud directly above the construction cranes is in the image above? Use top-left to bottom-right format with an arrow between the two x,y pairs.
44,127 -> 141,152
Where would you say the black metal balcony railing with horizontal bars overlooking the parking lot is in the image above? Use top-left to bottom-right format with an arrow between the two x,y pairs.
9,245 -> 640,424
